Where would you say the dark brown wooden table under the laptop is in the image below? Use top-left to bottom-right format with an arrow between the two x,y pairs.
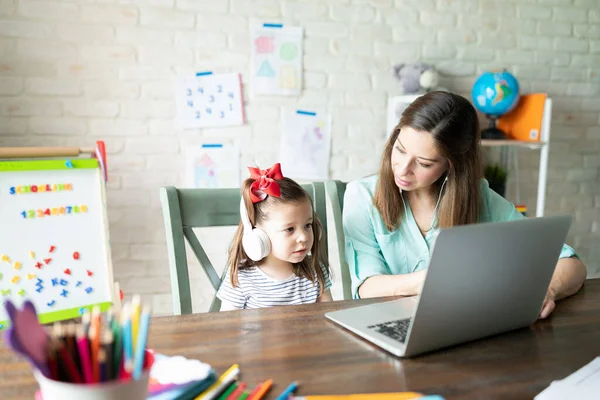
0,279 -> 600,399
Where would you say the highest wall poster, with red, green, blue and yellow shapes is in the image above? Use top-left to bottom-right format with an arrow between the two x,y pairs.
251,24 -> 303,96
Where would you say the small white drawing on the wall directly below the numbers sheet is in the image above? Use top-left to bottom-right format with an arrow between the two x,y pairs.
185,143 -> 241,189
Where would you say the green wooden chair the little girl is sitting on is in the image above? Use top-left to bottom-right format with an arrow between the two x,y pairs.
160,182 -> 327,315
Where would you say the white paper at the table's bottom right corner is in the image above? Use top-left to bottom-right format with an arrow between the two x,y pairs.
535,357 -> 600,400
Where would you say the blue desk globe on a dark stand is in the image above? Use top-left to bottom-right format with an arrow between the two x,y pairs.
471,70 -> 519,139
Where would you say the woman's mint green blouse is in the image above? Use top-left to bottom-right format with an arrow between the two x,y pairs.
343,175 -> 576,298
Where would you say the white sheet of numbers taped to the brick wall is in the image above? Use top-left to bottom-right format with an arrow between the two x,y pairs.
175,72 -> 244,129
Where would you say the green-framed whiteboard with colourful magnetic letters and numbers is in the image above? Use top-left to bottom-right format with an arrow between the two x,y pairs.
0,159 -> 113,328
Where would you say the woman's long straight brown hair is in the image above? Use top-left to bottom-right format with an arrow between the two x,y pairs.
373,91 -> 483,231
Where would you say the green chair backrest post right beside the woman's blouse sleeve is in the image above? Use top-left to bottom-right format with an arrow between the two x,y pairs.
325,180 -> 352,300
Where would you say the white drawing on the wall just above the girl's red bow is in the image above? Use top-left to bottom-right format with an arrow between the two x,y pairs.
280,109 -> 331,181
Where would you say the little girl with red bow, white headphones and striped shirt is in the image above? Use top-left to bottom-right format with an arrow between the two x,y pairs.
217,163 -> 332,311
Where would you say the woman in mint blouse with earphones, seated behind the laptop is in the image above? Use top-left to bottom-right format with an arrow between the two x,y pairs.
343,92 -> 587,318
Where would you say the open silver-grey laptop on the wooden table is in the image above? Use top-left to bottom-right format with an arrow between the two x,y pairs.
325,216 -> 572,357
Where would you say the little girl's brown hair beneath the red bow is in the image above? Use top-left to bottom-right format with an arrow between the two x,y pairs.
227,178 -> 329,294
